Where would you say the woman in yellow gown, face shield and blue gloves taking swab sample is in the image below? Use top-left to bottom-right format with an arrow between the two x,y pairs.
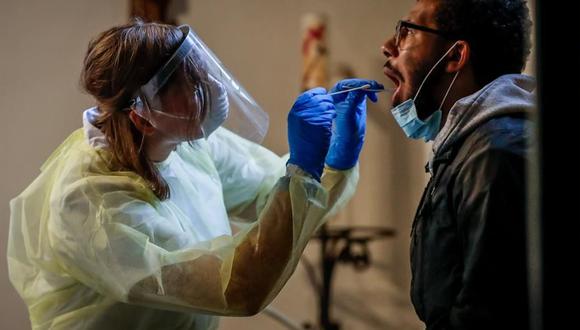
8,22 -> 380,330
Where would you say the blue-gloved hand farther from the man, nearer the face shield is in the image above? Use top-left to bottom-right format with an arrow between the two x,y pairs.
288,87 -> 336,181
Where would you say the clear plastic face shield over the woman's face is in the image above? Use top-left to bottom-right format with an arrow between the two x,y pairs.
131,25 -> 269,143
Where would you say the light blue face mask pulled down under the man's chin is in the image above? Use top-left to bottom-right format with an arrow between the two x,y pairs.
391,43 -> 459,142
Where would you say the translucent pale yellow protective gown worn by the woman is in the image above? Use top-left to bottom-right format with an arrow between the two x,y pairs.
8,109 -> 358,330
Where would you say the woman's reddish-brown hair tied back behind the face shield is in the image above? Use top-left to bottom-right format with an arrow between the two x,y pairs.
81,20 -> 207,200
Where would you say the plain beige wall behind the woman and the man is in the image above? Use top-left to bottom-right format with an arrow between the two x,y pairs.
0,0 -> 536,330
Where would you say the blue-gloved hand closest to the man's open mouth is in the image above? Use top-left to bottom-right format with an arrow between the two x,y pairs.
326,79 -> 384,170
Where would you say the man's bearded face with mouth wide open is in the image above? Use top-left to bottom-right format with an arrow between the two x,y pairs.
383,0 -> 444,118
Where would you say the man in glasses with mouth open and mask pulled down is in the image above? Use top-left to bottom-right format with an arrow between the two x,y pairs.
382,0 -> 535,330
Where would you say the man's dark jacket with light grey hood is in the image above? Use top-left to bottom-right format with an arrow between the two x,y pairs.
411,75 -> 535,330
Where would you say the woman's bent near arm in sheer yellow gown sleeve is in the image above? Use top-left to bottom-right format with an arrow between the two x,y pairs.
50,168 -> 353,315
